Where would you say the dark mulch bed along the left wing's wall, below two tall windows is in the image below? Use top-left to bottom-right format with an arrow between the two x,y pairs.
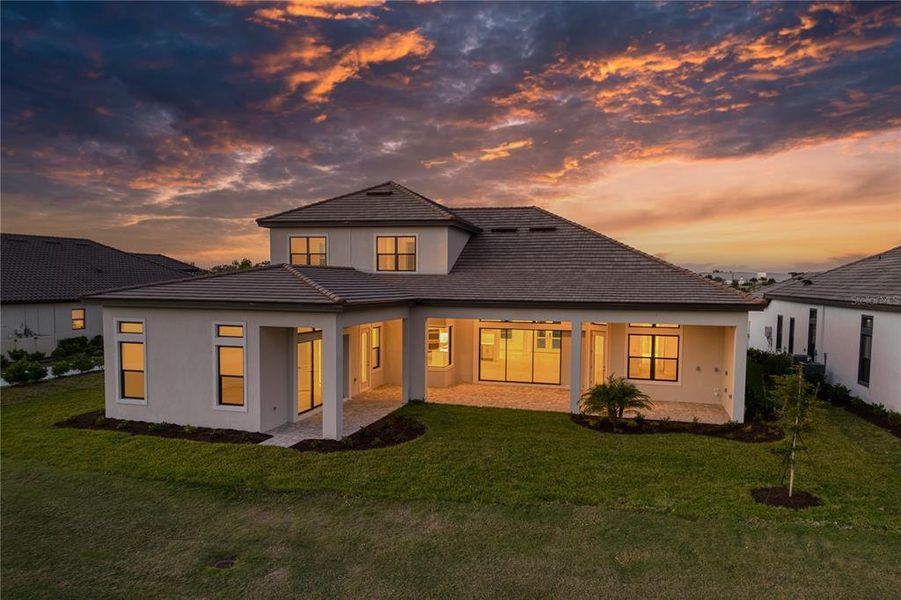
54,410 -> 272,444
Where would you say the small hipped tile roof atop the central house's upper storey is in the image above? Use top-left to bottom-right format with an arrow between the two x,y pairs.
257,181 -> 478,232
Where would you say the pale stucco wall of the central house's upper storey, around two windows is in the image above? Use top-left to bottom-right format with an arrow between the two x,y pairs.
269,227 -> 469,274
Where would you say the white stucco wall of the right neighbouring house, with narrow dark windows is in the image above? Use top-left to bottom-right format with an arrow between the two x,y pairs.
750,300 -> 901,411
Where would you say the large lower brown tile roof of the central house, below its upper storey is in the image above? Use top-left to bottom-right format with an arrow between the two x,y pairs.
88,202 -> 763,310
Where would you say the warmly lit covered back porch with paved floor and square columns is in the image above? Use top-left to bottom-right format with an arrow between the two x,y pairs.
262,306 -> 747,445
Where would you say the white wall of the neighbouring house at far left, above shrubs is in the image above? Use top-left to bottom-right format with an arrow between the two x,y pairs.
0,303 -> 103,354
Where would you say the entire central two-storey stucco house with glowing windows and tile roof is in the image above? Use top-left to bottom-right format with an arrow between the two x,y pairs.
90,182 -> 763,438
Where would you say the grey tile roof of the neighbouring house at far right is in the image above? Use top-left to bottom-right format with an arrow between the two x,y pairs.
764,246 -> 901,312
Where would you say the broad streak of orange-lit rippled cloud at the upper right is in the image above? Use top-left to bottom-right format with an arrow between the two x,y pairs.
492,3 -> 901,123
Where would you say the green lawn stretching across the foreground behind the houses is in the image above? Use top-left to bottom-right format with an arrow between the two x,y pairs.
0,375 -> 901,598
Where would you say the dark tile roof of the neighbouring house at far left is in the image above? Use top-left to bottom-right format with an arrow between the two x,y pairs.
0,233 -> 185,304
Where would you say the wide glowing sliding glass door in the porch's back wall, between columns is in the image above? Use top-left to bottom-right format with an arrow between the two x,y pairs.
479,328 -> 563,384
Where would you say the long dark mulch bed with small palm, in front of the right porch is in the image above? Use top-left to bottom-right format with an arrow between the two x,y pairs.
570,415 -> 785,444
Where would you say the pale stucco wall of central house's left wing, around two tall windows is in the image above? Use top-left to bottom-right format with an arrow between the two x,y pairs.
103,307 -> 336,431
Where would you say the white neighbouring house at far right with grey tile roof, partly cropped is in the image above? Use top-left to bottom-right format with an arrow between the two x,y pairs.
749,246 -> 901,411
